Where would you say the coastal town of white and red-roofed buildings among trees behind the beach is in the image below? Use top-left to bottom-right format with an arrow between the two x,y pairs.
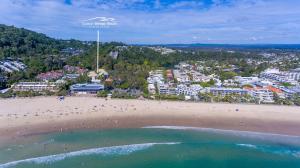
0,46 -> 300,105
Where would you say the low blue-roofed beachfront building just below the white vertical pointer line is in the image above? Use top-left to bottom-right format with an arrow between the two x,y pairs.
70,83 -> 104,94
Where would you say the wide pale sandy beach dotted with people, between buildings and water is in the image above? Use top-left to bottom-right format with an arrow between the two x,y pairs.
0,97 -> 300,142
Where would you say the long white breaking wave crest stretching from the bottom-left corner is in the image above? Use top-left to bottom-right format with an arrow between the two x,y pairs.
0,142 -> 179,168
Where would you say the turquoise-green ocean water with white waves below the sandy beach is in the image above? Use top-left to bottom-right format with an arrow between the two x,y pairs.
0,126 -> 300,168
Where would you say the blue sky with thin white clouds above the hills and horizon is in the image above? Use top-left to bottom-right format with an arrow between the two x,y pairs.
0,0 -> 300,44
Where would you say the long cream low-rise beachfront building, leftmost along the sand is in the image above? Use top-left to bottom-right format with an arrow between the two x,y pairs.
13,82 -> 58,92
